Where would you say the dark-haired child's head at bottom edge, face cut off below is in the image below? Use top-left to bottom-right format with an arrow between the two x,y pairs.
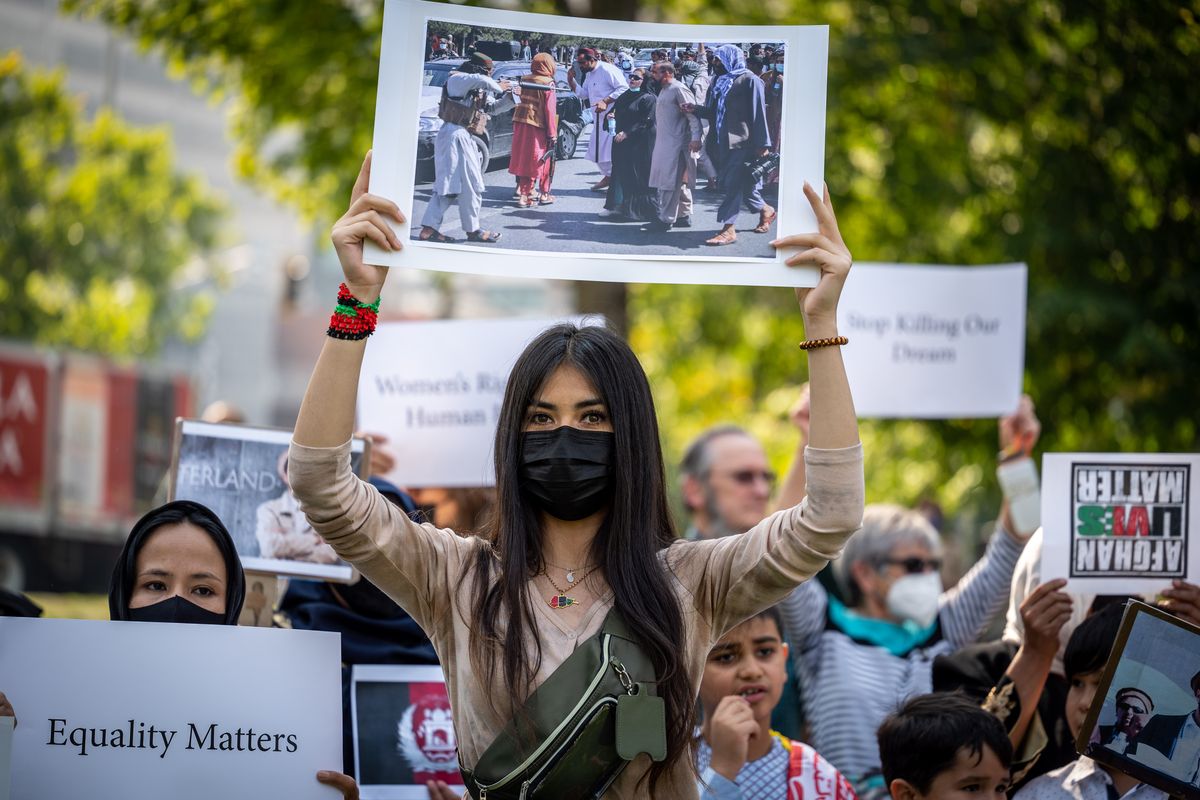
877,692 -> 1013,800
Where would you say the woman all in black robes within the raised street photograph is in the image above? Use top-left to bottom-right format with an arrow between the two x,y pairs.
600,68 -> 658,221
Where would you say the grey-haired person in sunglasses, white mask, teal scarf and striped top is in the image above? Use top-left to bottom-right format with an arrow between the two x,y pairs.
781,402 -> 1038,789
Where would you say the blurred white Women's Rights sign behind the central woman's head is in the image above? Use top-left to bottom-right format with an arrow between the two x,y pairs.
359,317 -> 602,487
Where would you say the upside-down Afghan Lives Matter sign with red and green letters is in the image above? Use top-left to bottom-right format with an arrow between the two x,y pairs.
1042,453 -> 1200,595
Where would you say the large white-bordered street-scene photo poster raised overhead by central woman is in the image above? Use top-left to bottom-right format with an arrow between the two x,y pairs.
366,0 -> 829,287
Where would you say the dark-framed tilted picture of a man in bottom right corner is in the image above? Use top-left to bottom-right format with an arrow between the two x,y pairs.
1075,601 -> 1200,799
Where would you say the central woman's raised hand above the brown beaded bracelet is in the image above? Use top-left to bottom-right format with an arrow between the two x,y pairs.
770,181 -> 854,328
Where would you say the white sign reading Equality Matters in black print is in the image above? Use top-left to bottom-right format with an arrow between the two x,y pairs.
0,618 -> 342,800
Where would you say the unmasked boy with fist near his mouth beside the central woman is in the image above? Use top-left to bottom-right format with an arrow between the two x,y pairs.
696,608 -> 857,800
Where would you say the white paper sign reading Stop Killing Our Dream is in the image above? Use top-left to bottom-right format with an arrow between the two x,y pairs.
838,264 -> 1027,420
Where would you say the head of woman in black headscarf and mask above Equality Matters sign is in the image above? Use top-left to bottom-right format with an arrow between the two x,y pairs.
108,500 -> 246,625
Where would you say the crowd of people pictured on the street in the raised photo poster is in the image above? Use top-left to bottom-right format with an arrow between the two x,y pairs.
416,34 -> 786,247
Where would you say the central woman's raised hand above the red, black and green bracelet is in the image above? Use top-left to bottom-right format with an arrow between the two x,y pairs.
330,152 -> 404,302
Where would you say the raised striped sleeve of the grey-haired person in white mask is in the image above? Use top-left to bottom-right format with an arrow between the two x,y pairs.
938,525 -> 1025,648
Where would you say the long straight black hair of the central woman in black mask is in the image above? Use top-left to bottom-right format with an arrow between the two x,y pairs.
470,324 -> 695,792
